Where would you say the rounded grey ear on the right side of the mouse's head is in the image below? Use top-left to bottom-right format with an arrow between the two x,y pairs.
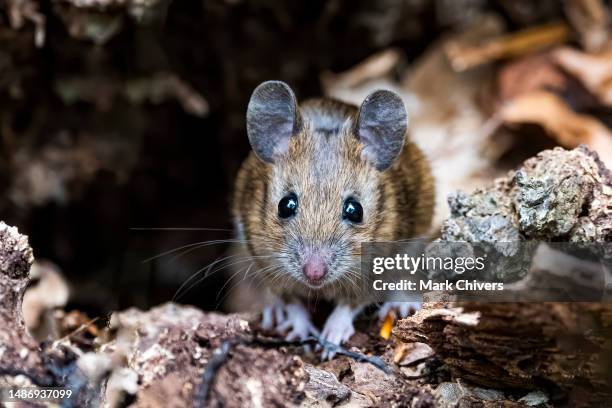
355,90 -> 408,171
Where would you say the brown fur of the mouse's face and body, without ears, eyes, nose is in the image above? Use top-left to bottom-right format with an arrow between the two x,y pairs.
232,99 -> 434,300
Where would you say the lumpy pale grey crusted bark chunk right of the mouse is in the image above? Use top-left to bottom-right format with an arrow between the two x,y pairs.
442,146 -> 612,243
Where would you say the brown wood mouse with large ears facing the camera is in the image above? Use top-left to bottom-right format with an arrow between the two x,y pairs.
232,81 -> 434,357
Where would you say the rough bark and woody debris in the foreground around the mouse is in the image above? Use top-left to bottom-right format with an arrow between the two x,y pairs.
0,147 -> 612,407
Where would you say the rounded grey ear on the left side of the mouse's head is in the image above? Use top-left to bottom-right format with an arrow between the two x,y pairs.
247,81 -> 300,163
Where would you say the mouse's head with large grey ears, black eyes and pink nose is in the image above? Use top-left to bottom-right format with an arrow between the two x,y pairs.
247,81 -> 407,289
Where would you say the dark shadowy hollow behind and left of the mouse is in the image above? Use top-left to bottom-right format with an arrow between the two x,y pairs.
0,0 -> 561,314
